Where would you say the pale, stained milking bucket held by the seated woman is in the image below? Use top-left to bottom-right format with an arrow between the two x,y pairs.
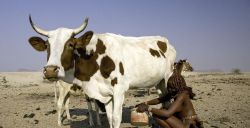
130,109 -> 148,126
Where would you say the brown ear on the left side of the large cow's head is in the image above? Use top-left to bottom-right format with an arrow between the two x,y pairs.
29,36 -> 47,51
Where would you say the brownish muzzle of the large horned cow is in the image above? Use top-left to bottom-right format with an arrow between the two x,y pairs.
43,65 -> 59,81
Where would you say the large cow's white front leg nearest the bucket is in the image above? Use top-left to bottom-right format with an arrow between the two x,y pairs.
113,90 -> 124,128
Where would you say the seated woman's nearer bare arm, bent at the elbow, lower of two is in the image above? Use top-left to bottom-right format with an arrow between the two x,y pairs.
148,94 -> 185,117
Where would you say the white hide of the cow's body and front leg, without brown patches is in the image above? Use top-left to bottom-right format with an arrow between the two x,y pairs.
73,33 -> 176,128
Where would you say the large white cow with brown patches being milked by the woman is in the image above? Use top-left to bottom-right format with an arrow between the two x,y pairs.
27,15 -> 176,128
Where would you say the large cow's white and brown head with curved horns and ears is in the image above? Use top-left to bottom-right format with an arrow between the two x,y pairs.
29,16 -> 93,81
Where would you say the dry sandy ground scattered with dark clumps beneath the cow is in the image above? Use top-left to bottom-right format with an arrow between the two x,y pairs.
0,72 -> 250,128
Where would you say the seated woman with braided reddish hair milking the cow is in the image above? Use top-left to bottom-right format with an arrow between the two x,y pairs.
137,60 -> 203,128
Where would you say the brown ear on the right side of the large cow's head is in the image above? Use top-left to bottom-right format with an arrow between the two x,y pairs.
75,31 -> 94,49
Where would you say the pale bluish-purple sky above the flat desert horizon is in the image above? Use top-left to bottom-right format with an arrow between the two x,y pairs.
0,0 -> 250,72
